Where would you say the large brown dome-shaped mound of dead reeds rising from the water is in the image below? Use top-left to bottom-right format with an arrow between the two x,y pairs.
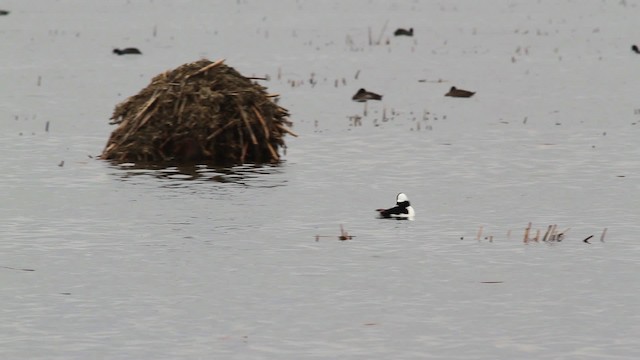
101,59 -> 297,165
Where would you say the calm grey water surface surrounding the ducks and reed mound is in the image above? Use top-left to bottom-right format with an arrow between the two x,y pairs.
0,0 -> 640,359
